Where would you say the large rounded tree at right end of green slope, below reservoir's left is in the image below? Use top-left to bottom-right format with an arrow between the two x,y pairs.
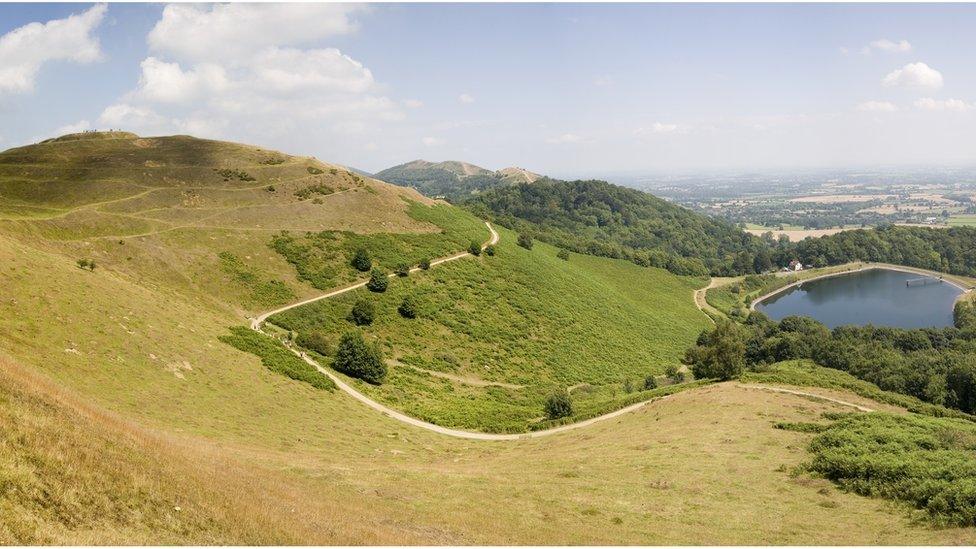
685,320 -> 747,381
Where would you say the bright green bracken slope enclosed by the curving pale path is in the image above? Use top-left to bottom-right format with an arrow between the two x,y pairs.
269,230 -> 708,431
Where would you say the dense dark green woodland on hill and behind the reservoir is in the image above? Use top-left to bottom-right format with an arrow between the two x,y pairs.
467,179 -> 976,276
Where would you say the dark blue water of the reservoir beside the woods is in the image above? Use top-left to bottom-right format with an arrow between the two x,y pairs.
756,269 -> 963,328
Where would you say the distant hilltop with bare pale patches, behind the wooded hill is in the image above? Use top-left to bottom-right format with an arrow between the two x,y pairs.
376,160 -> 542,202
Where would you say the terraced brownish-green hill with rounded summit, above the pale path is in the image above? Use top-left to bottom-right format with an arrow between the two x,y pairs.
0,133 -> 484,313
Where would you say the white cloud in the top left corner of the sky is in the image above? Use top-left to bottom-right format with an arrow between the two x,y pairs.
0,4 -> 108,94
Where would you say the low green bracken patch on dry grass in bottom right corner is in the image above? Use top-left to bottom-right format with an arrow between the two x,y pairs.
809,412 -> 976,526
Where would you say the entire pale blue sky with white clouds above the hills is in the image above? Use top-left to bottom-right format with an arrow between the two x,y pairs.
0,4 -> 976,177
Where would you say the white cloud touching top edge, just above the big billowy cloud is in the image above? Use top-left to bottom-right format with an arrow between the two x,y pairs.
148,3 -> 364,63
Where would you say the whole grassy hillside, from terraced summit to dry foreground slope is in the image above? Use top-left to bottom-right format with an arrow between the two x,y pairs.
0,133 -> 974,545
